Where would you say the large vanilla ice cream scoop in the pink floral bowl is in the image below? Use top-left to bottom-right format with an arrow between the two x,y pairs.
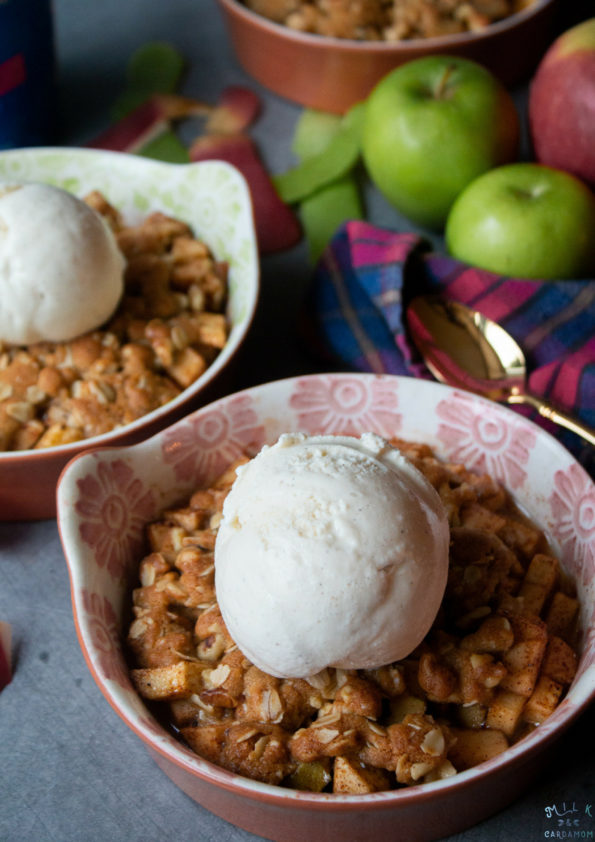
215,433 -> 449,678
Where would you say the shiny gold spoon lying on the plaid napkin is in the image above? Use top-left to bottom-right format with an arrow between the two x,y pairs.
407,295 -> 595,445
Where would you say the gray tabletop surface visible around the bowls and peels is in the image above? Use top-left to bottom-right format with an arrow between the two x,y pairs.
0,0 -> 595,842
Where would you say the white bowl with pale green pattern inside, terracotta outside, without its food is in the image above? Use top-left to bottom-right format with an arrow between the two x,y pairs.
0,148 -> 259,520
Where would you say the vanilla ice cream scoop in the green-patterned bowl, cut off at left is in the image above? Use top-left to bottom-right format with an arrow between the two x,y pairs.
0,183 -> 124,345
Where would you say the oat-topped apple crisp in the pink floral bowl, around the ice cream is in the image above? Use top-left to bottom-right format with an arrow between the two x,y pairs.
127,439 -> 578,793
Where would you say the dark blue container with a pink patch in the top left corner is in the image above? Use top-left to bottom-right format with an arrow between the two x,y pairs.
0,0 -> 56,149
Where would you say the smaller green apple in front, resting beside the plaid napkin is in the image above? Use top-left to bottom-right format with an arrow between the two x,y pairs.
445,163 -> 595,280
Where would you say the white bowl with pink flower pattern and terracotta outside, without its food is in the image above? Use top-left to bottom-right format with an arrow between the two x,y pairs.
57,374 -> 595,842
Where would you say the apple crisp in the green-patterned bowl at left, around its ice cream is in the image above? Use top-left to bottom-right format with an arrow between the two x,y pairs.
0,192 -> 229,451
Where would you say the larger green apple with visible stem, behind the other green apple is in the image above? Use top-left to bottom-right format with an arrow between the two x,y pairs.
362,55 -> 520,229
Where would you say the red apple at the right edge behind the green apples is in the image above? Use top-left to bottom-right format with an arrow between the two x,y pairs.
529,18 -> 595,186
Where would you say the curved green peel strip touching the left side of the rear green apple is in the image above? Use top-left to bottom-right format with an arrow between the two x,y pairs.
273,103 -> 363,204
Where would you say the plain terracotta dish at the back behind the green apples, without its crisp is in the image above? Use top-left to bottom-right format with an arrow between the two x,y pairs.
218,0 -> 557,114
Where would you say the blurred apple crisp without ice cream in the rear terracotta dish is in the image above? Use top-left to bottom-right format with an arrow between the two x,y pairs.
244,0 -> 533,41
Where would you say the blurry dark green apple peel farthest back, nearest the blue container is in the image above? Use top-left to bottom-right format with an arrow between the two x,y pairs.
111,41 -> 185,120
